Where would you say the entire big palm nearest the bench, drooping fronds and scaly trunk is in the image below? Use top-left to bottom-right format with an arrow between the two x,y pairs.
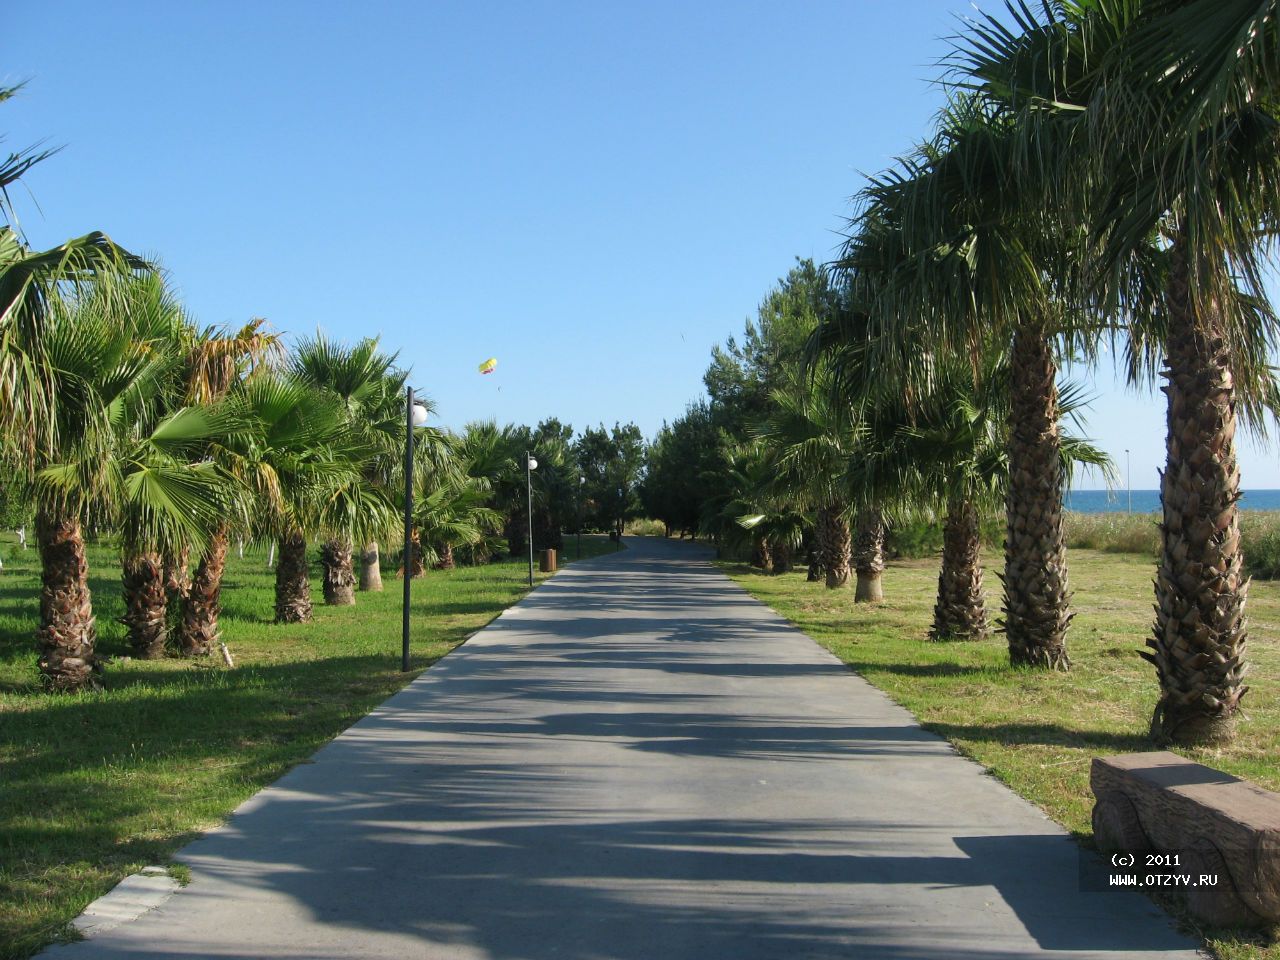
964,0 -> 1280,744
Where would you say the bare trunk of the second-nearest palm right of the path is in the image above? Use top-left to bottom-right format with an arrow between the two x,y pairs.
1004,323 -> 1073,669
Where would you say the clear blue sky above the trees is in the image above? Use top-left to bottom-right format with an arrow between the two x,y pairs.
10,0 -> 1280,488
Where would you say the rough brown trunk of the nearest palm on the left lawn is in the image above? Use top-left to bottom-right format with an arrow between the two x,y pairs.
36,511 -> 97,690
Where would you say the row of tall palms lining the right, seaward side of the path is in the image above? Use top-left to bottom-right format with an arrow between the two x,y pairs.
655,0 -> 1280,744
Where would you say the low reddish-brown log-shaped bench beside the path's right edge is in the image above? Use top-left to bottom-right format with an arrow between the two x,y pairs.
1089,751 -> 1280,925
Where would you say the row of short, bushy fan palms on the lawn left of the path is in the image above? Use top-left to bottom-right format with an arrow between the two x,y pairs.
5,264 -> 524,690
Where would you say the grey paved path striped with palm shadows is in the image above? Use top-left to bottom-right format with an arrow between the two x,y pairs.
47,540 -> 1197,960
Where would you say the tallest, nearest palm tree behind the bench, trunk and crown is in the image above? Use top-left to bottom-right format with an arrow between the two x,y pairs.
1089,3 -> 1280,744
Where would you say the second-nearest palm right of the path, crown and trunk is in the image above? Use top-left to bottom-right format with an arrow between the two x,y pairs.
841,97 -> 1098,669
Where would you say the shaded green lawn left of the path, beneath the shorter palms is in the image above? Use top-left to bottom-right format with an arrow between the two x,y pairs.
0,536 -> 614,960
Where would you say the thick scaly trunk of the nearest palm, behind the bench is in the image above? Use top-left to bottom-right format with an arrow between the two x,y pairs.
1142,237 -> 1249,745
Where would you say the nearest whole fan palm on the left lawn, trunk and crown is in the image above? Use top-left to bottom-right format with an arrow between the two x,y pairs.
28,278 -> 221,690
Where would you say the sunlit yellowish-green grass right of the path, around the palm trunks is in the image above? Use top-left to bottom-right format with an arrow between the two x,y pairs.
722,550 -> 1280,960
